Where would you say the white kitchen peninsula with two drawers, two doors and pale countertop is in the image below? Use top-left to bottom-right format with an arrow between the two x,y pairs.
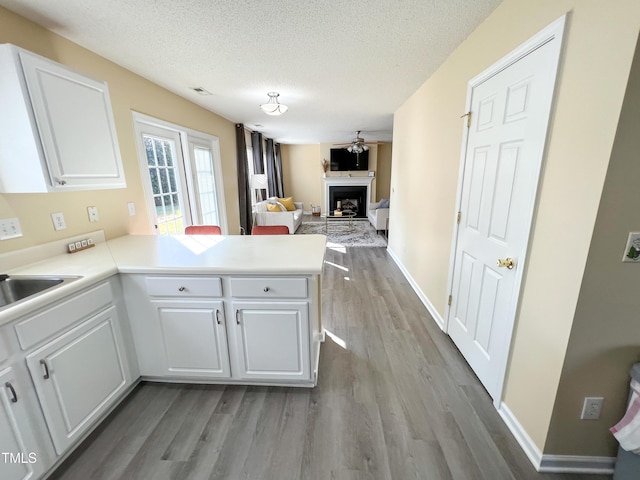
109,235 -> 325,386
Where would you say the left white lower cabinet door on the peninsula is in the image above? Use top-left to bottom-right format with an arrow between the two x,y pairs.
151,301 -> 231,378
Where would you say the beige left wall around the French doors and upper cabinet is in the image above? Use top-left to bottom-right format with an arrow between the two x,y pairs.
0,7 -> 239,253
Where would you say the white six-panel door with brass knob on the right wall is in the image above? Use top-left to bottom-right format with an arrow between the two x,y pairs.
447,19 -> 564,401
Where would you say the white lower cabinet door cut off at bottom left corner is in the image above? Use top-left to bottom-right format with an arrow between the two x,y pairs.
0,368 -> 48,480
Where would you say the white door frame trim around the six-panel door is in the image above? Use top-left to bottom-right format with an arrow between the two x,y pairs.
443,14 -> 567,407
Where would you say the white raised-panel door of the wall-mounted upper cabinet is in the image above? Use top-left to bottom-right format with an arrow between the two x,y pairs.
20,51 -> 126,189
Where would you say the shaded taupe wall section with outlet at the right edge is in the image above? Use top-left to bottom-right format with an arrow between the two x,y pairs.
545,34 -> 640,455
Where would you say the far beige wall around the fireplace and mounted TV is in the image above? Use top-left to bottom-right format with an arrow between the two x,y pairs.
281,143 -> 392,212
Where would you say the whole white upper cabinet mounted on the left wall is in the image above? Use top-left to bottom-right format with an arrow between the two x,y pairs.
0,44 -> 126,193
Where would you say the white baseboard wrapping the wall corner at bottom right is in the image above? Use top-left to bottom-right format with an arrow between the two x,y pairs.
498,402 -> 616,475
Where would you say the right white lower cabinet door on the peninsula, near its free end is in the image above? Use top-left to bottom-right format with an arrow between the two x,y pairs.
233,302 -> 310,380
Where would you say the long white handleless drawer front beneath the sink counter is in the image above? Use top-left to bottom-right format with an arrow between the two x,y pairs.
15,283 -> 112,350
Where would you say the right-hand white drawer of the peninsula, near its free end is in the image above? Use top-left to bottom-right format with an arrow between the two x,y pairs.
231,277 -> 308,298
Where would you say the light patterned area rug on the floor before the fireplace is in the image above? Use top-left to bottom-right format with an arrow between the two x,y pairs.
296,220 -> 387,247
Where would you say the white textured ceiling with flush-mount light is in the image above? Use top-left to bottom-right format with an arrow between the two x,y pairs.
0,0 -> 500,144
